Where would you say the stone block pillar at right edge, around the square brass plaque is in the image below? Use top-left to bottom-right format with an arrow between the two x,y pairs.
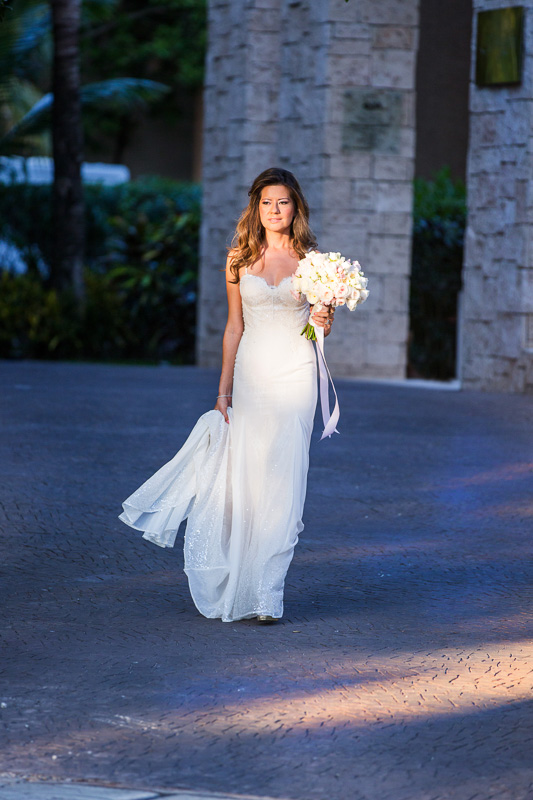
460,0 -> 533,392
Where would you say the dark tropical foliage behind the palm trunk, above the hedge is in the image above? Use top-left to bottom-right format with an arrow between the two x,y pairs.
0,0 -> 206,155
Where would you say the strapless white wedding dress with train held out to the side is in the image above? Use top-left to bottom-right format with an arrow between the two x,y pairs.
120,274 -> 317,622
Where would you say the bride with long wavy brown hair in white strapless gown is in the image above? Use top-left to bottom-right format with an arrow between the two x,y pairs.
119,168 -> 333,623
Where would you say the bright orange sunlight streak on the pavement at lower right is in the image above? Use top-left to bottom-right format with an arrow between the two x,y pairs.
88,640 -> 533,735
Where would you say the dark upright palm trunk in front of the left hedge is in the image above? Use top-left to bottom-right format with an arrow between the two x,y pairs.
50,0 -> 85,300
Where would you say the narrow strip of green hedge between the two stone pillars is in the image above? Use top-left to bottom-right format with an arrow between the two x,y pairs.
409,169 -> 466,380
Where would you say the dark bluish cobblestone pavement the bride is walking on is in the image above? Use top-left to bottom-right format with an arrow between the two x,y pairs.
0,362 -> 533,800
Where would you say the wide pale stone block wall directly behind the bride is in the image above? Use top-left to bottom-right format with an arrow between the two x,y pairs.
198,0 -> 418,378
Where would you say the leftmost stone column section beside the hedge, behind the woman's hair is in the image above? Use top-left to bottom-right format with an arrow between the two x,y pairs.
197,0 -> 281,366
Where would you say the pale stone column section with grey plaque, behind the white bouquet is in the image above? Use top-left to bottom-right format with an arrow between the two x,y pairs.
310,0 -> 418,378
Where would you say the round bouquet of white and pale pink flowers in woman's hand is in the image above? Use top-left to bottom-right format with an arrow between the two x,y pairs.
291,250 -> 368,341
